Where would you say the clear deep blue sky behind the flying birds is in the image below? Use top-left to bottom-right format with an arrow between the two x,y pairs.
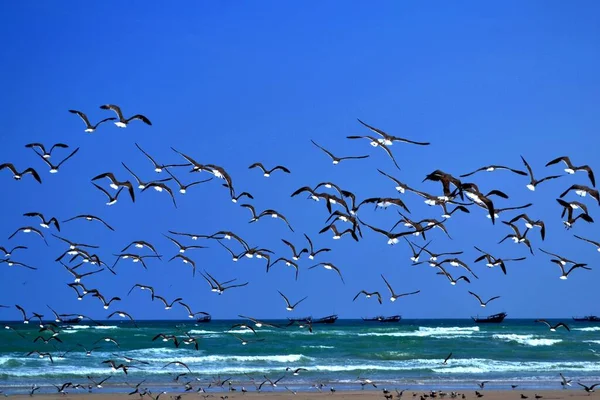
0,1 -> 600,319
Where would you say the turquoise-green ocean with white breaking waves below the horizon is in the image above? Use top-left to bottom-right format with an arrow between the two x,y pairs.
0,319 -> 600,394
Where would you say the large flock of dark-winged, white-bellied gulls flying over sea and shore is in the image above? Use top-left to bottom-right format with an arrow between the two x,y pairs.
0,104 -> 600,400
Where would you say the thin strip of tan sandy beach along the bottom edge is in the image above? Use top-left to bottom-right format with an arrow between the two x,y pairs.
10,388 -> 600,400
